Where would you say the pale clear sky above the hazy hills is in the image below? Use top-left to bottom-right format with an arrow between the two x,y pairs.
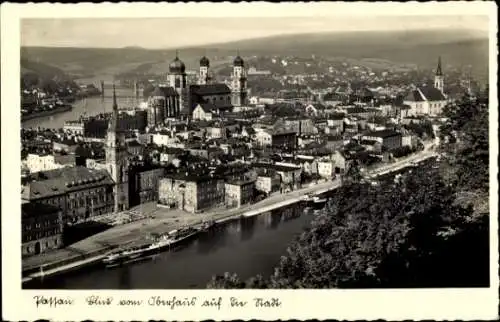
21,15 -> 488,48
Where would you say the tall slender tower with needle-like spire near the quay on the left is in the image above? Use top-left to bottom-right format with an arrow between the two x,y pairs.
105,84 -> 129,212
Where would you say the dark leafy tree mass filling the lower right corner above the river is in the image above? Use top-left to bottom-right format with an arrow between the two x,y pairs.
209,91 -> 489,288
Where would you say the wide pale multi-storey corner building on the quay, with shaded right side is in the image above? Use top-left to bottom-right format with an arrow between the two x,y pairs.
159,172 -> 225,213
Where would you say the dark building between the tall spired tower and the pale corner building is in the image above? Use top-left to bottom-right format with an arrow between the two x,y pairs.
129,164 -> 165,207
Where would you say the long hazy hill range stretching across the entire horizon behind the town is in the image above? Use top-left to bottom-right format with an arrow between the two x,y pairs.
21,30 -> 488,81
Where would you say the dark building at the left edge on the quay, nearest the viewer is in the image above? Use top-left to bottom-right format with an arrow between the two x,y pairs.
21,202 -> 64,257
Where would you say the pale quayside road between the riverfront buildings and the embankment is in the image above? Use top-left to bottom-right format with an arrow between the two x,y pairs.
23,143 -> 435,269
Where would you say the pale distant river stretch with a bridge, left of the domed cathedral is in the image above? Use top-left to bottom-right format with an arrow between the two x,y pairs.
21,88 -> 139,129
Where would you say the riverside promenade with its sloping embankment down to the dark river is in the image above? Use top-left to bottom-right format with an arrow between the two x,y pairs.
22,143 -> 435,282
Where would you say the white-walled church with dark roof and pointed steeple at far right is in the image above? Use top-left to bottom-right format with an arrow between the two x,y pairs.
404,57 -> 448,116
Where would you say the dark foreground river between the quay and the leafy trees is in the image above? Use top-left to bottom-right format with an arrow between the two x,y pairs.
25,205 -> 313,289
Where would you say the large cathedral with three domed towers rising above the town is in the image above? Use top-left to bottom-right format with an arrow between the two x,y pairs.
148,54 -> 247,126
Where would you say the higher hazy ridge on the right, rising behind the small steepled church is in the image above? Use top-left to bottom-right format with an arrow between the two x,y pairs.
204,30 -> 488,67
